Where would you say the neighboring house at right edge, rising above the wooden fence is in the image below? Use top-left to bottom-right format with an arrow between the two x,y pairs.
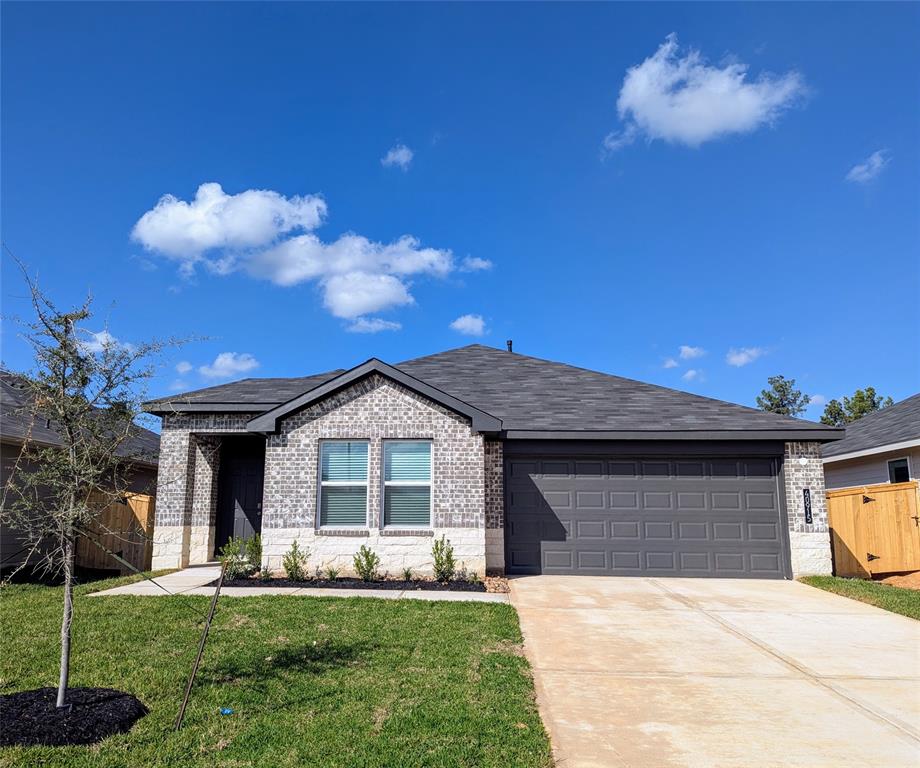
822,394 -> 920,489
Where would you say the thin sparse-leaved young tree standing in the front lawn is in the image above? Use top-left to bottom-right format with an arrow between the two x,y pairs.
0,272 -> 177,707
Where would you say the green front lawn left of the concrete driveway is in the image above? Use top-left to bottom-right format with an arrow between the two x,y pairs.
0,578 -> 551,768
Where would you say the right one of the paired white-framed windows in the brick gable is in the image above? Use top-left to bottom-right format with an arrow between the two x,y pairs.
383,440 -> 431,528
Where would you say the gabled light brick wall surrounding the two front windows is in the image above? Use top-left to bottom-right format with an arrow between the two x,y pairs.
262,375 -> 486,575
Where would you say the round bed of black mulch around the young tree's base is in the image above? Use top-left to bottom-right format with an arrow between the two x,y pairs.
0,688 -> 147,747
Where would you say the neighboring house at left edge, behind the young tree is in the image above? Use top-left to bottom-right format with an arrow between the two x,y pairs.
0,371 -> 160,571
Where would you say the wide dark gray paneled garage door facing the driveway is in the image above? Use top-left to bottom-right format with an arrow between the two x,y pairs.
505,456 -> 789,578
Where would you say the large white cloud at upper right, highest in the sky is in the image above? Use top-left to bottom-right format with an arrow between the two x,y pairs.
604,34 -> 806,152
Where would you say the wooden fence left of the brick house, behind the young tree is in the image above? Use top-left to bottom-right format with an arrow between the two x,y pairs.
76,493 -> 155,575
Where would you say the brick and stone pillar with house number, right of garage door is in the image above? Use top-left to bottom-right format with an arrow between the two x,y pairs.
783,442 -> 832,576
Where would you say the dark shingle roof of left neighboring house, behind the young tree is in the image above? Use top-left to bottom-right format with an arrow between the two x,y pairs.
0,371 -> 160,466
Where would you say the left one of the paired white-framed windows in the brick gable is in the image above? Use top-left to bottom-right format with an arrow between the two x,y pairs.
318,440 -> 368,528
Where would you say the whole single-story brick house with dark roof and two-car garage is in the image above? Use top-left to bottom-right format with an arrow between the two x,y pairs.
147,343 -> 843,578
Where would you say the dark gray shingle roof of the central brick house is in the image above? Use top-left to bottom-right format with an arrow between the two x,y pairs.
148,344 -> 842,440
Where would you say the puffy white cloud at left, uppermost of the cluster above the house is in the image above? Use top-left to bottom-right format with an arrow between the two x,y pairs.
131,183 -> 326,260
